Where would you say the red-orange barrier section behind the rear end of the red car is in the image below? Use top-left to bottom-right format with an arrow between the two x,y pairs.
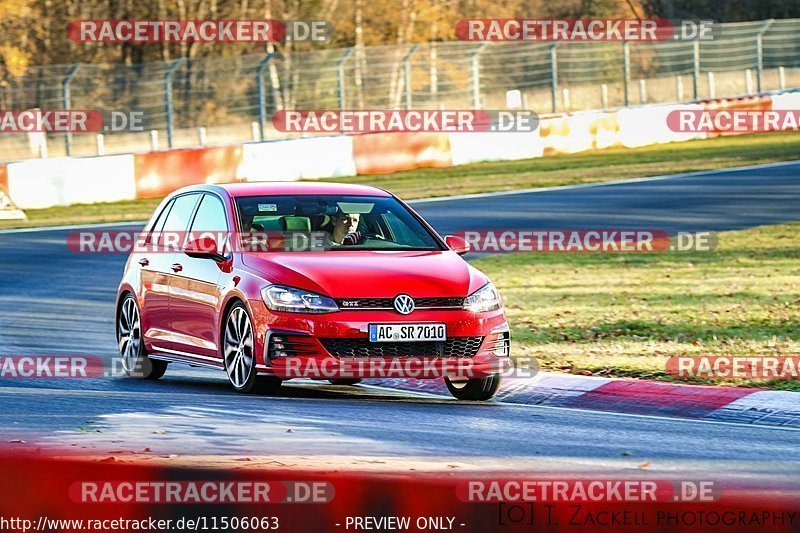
133,146 -> 242,198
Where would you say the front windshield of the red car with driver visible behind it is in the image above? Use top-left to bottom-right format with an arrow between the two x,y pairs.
231,195 -> 445,251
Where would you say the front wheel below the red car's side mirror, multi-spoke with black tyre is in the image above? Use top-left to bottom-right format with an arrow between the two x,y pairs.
220,302 -> 283,394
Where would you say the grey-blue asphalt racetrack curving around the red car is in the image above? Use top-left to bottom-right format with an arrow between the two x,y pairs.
0,163 -> 800,482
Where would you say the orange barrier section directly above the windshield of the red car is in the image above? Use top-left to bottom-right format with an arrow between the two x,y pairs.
353,132 -> 453,174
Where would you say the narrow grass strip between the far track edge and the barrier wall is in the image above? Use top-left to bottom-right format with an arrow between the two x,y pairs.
0,133 -> 800,229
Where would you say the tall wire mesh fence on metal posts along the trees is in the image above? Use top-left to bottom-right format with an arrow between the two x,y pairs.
0,19 -> 800,160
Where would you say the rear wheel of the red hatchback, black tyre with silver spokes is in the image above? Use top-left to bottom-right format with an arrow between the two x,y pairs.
117,294 -> 169,379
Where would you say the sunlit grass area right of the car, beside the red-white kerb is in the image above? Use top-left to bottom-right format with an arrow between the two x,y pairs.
473,223 -> 800,391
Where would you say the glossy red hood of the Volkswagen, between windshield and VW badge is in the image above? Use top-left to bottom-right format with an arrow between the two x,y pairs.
242,250 -> 488,298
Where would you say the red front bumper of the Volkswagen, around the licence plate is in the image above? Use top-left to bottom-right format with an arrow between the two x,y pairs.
250,301 -> 510,379
